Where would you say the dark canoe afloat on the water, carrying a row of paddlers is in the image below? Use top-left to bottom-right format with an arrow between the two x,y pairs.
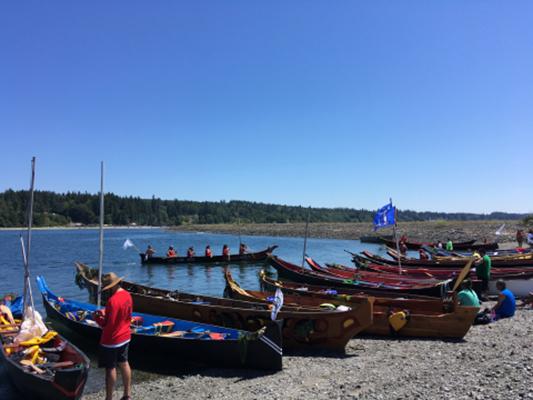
139,245 -> 278,264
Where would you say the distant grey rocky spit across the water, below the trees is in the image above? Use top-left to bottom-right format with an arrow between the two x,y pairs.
170,220 -> 527,242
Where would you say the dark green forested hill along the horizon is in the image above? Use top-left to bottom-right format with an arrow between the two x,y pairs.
0,190 -> 525,227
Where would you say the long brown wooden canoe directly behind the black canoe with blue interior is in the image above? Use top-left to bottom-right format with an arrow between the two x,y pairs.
74,264 -> 373,351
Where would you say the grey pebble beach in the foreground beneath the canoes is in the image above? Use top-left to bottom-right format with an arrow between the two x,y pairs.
84,304 -> 533,400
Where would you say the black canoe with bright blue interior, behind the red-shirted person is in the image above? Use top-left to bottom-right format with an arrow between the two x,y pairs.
37,277 -> 282,371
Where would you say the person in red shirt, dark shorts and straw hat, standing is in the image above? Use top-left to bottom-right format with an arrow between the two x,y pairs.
94,272 -> 133,400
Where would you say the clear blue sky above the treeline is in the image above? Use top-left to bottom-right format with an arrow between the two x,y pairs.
0,0 -> 533,212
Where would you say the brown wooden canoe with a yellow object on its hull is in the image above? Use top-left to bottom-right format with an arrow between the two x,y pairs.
225,271 -> 478,339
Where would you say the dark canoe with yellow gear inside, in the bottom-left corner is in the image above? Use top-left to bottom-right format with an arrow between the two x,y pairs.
0,318 -> 89,400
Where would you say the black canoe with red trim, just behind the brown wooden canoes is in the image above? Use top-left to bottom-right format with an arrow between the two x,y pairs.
269,256 -> 450,297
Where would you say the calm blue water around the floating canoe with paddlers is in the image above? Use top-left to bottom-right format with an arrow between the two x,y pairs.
0,229 -> 384,400
